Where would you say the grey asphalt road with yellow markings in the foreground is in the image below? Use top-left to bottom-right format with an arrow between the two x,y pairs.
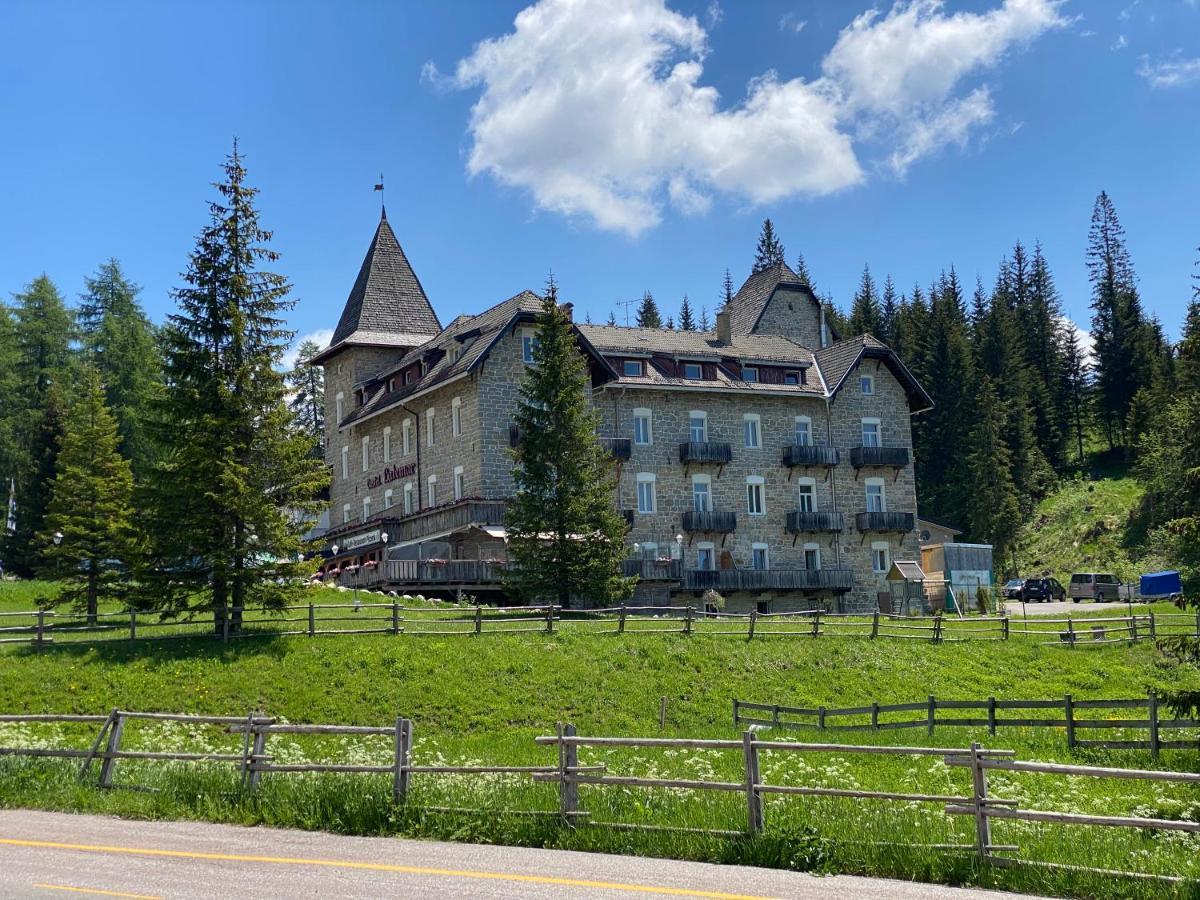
0,810 -> 1041,900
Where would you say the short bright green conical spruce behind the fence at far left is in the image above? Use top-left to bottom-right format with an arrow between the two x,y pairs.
37,366 -> 142,625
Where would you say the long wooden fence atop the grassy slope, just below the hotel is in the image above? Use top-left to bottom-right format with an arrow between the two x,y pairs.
0,600 -> 1200,649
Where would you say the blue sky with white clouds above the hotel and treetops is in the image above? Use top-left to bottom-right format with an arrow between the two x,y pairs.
0,0 -> 1200,360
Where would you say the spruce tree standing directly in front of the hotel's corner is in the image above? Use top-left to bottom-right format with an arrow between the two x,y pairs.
505,280 -> 634,606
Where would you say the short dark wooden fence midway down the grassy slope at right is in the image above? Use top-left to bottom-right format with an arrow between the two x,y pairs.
733,691 -> 1200,758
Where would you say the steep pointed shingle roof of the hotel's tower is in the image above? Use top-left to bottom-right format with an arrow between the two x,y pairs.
313,211 -> 442,362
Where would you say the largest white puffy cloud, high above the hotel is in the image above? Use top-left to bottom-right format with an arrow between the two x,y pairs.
434,0 -> 1067,235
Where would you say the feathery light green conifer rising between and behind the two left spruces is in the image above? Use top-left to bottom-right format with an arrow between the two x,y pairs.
78,259 -> 162,479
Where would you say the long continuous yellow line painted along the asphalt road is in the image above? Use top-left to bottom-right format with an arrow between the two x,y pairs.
0,838 -> 772,900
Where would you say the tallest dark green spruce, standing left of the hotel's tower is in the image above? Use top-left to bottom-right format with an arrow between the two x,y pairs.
148,143 -> 329,634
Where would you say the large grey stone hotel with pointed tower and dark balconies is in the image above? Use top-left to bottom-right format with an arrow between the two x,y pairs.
317,215 -> 931,611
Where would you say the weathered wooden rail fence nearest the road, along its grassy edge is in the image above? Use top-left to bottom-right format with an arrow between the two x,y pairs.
0,709 -> 1200,882
